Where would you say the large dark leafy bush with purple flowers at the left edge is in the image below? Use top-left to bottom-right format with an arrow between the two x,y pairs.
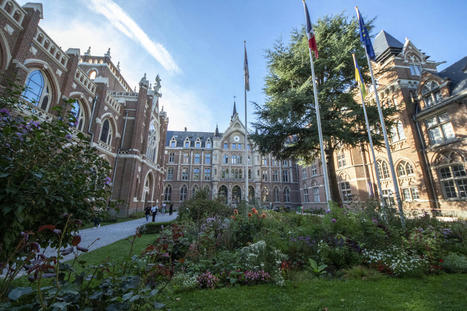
0,85 -> 110,266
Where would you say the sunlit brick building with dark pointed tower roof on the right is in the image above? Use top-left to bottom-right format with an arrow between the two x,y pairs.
300,31 -> 467,217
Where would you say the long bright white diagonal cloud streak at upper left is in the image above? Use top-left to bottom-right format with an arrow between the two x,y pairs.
82,0 -> 180,73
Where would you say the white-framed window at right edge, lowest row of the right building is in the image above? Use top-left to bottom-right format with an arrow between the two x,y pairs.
438,163 -> 467,199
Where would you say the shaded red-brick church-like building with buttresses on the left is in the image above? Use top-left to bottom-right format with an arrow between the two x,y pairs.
0,0 -> 168,214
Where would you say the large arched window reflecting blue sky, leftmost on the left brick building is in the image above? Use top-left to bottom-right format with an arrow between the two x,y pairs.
21,70 -> 51,111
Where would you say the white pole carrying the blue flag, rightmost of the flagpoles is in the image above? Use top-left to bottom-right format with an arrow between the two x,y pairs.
365,47 -> 405,230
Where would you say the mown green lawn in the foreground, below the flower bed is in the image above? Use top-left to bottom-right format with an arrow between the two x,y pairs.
165,274 -> 467,311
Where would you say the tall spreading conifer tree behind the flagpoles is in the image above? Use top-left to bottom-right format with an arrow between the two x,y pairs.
251,14 -> 395,204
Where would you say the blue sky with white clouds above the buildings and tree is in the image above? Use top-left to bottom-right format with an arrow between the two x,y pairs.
19,0 -> 467,131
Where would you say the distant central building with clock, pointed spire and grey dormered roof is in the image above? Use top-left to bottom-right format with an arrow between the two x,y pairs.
163,103 -> 300,208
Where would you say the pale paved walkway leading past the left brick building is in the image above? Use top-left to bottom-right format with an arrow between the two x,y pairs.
45,212 -> 177,261
